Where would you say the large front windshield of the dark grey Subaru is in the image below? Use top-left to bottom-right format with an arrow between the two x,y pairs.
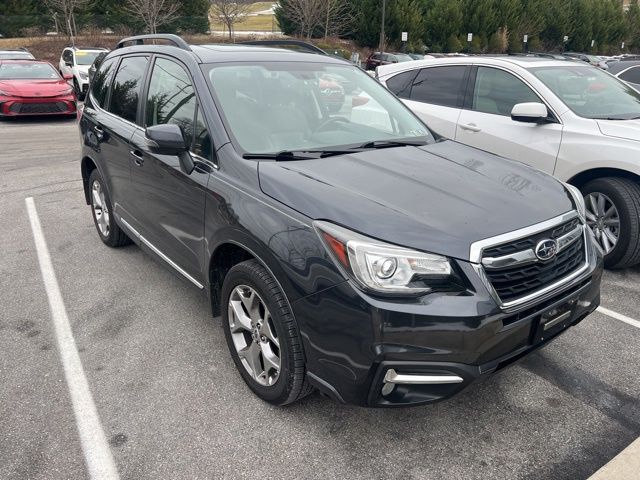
204,62 -> 434,153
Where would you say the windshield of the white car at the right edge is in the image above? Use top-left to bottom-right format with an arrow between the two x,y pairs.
531,65 -> 640,120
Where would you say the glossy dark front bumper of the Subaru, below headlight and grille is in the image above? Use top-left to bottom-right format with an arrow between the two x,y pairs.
292,236 -> 602,406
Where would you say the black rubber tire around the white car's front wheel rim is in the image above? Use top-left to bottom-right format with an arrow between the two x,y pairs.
581,177 -> 640,269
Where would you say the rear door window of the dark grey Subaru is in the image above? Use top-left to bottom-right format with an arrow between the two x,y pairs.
109,57 -> 149,123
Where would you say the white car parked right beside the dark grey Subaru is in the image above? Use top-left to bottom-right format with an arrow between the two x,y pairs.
376,57 -> 640,268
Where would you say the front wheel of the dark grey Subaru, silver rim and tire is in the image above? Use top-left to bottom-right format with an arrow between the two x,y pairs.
221,260 -> 313,405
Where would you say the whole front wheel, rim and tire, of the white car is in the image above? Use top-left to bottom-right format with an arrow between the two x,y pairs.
582,177 -> 640,268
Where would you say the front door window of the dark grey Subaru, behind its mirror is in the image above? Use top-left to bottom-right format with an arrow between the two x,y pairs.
145,58 -> 211,159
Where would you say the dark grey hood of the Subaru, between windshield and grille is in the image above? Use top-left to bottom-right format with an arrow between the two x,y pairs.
259,140 -> 573,260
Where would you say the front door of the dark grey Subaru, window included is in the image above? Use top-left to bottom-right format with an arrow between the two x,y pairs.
131,56 -> 215,284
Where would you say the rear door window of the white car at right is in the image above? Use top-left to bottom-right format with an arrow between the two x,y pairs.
410,65 -> 467,108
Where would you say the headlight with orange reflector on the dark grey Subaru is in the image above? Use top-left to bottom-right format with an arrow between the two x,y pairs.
313,221 -> 457,295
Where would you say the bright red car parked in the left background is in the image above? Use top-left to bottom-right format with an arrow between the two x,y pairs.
0,60 -> 76,117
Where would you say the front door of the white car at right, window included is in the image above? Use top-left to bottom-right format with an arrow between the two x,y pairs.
455,66 -> 562,174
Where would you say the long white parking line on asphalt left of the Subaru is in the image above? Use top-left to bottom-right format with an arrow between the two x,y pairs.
25,197 -> 119,480
